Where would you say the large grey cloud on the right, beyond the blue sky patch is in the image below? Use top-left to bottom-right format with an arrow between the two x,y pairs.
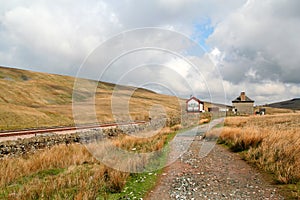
208,0 -> 300,84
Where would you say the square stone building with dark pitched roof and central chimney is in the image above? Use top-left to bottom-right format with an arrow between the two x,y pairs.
232,92 -> 254,115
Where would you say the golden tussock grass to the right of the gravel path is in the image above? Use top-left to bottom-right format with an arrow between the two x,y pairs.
207,113 -> 300,189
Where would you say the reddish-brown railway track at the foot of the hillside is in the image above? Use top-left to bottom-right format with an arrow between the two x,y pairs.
0,121 -> 146,138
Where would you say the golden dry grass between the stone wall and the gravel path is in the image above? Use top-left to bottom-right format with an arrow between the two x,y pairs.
0,128 -> 176,199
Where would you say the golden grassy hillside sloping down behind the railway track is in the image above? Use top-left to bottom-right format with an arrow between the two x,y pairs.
0,67 -> 180,130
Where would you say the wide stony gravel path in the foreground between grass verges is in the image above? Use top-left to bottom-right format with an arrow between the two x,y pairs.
146,127 -> 284,200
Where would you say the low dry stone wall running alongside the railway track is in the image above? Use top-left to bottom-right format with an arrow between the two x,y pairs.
0,114 -> 206,157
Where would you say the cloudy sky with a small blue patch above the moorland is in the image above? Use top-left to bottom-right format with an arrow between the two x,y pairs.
0,0 -> 300,105
